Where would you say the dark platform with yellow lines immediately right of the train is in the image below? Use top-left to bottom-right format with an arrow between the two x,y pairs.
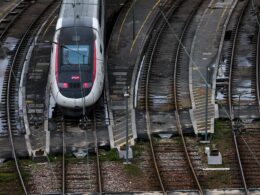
106,0 -> 160,147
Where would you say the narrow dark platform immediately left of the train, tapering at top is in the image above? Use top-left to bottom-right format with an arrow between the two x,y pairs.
19,1 -> 60,158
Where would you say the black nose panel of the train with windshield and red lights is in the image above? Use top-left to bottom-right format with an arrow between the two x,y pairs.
55,27 -> 96,98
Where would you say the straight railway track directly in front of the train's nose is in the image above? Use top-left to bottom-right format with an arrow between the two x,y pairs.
61,108 -> 102,194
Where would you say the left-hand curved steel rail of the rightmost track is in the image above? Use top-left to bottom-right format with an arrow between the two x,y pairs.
228,0 -> 249,194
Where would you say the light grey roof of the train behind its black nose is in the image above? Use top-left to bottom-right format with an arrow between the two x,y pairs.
56,0 -> 100,30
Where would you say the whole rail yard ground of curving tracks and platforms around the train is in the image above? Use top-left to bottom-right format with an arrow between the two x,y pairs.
0,0 -> 260,194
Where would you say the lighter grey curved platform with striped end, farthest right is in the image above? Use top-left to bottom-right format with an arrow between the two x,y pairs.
189,0 -> 234,134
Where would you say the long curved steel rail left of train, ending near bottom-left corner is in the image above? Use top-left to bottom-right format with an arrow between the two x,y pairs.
6,3 -> 59,195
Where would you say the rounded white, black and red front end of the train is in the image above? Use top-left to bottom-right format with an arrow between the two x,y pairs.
51,27 -> 104,109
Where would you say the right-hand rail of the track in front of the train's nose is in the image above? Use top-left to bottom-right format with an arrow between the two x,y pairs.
92,106 -> 102,195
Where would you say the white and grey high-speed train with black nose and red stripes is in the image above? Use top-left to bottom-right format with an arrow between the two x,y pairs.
50,0 -> 105,112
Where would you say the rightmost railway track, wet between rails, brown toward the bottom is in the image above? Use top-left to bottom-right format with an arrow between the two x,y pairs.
216,1 -> 259,194
